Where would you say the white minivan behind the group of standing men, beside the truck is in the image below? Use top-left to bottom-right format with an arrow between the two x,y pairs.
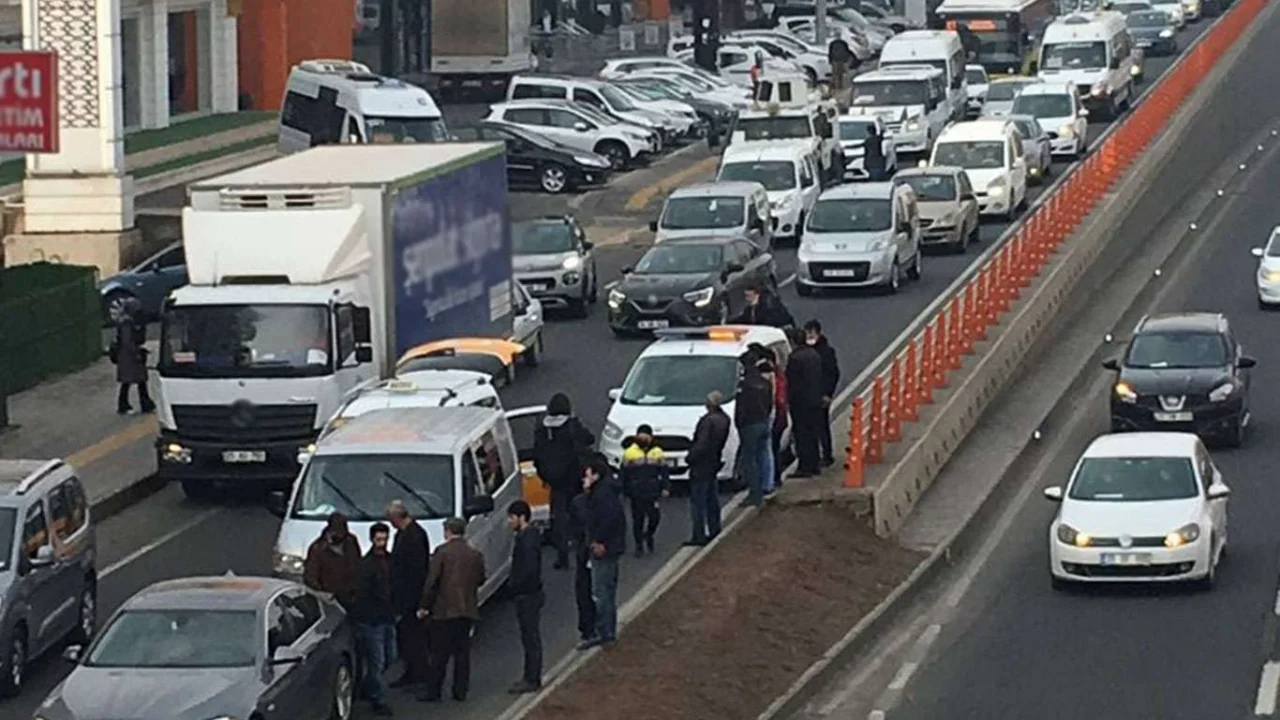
270,406 -> 540,602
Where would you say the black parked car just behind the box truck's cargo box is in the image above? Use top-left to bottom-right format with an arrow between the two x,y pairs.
457,120 -> 611,195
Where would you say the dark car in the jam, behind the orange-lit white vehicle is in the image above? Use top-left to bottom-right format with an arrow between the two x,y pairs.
609,237 -> 777,336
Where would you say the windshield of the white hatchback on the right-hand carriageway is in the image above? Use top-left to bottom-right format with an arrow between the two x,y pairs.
1070,457 -> 1199,502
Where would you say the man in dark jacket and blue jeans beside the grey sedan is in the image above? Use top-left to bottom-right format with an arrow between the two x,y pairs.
355,523 -> 396,715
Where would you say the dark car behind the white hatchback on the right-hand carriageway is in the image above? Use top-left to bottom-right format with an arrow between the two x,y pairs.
1102,313 -> 1257,447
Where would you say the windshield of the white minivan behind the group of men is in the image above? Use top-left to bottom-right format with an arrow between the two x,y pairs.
291,450 -> 453,523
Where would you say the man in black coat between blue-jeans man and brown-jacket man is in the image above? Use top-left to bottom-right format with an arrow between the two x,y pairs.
387,500 -> 431,688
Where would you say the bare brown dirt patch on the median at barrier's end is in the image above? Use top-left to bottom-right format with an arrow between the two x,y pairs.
529,505 -> 924,720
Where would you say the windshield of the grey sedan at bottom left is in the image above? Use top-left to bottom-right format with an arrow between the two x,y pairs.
84,610 -> 260,667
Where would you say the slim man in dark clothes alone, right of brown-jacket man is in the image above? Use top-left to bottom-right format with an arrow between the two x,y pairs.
507,500 -> 545,694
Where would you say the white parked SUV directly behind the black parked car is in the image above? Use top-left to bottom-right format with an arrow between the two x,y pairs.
485,100 -> 660,169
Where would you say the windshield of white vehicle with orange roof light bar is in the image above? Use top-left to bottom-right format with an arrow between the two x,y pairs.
621,355 -> 737,407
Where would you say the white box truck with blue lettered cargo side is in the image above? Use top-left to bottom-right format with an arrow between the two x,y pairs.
149,143 -> 513,497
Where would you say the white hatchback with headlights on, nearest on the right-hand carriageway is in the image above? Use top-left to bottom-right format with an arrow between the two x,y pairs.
1044,433 -> 1231,589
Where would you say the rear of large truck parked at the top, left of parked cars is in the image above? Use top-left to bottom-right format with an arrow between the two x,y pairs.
430,0 -> 536,97
